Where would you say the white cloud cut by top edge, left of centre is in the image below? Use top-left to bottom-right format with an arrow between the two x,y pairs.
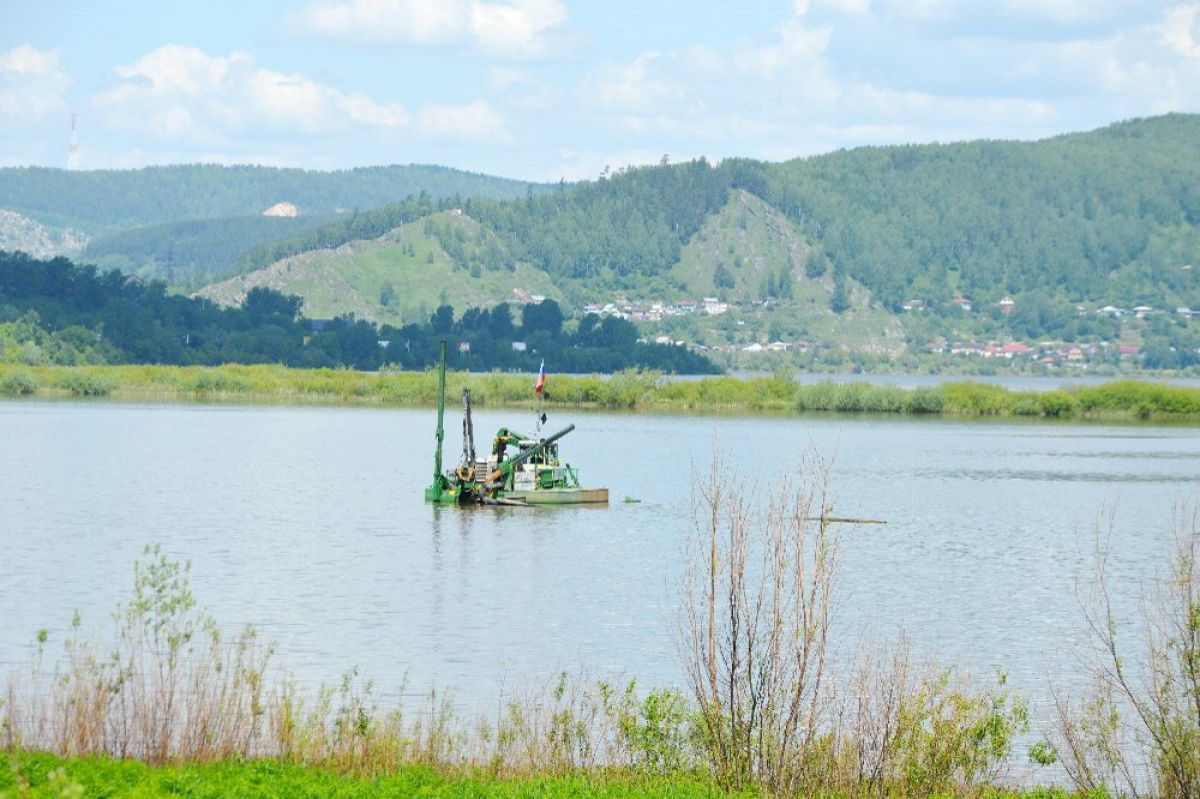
293,0 -> 566,59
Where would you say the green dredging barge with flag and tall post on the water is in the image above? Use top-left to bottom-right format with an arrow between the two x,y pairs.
425,342 -> 608,506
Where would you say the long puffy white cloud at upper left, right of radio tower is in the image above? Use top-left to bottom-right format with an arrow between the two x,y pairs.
95,44 -> 409,142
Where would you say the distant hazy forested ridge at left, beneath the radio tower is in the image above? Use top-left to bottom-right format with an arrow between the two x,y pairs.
0,164 -> 548,235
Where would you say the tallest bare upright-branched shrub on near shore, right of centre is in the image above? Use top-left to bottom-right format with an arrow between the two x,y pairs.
682,453 -> 838,793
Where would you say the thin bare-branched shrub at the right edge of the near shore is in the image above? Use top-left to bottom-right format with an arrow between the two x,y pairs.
1051,494 -> 1200,799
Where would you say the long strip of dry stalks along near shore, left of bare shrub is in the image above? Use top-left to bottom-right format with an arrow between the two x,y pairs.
0,548 -> 697,776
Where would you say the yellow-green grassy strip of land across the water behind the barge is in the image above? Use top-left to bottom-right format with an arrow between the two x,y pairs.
0,364 -> 1200,420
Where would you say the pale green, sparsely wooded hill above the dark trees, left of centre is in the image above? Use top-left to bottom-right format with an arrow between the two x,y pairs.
198,212 -> 563,325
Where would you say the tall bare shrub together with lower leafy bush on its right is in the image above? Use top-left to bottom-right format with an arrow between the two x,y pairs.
680,458 -> 1027,797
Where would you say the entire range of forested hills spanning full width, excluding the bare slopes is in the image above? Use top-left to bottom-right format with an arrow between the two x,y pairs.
0,114 -> 1200,330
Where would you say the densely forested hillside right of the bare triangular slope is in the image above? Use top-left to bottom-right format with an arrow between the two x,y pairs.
752,114 -> 1200,308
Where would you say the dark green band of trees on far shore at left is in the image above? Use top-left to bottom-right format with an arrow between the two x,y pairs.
0,252 -> 719,374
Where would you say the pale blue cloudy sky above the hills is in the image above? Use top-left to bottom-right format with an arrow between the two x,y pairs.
0,0 -> 1200,181
